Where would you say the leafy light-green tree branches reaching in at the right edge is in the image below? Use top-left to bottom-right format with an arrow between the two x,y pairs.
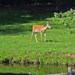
54,9 -> 75,29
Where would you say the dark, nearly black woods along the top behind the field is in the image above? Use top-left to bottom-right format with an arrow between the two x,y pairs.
0,0 -> 75,9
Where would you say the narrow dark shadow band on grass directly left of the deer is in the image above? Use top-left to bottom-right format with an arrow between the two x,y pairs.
0,25 -> 32,35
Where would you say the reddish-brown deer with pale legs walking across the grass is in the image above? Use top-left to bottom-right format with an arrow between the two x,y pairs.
30,21 -> 51,42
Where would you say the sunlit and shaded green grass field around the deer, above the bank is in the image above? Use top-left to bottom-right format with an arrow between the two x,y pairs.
0,9 -> 75,64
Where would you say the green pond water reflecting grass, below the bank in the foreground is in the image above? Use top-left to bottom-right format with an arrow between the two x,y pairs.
0,64 -> 68,75
